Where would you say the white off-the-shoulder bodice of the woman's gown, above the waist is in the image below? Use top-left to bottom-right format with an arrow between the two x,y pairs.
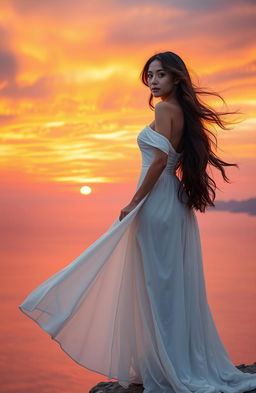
137,126 -> 182,173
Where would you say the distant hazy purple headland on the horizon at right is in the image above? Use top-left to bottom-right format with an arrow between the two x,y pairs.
207,198 -> 256,216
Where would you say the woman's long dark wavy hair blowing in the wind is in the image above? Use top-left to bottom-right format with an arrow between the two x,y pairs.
140,52 -> 241,213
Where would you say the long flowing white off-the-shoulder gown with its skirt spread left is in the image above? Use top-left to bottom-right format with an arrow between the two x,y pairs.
18,126 -> 256,393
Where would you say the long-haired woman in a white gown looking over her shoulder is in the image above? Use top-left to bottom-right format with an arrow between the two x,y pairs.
19,52 -> 256,393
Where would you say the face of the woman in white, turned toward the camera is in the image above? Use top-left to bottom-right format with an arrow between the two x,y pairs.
147,60 -> 175,99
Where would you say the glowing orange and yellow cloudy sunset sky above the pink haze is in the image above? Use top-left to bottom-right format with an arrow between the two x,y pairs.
0,0 -> 256,191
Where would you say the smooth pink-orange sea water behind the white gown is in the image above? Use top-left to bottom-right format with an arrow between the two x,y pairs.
0,202 -> 256,393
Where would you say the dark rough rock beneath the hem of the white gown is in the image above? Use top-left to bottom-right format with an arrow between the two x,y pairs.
89,362 -> 256,393
